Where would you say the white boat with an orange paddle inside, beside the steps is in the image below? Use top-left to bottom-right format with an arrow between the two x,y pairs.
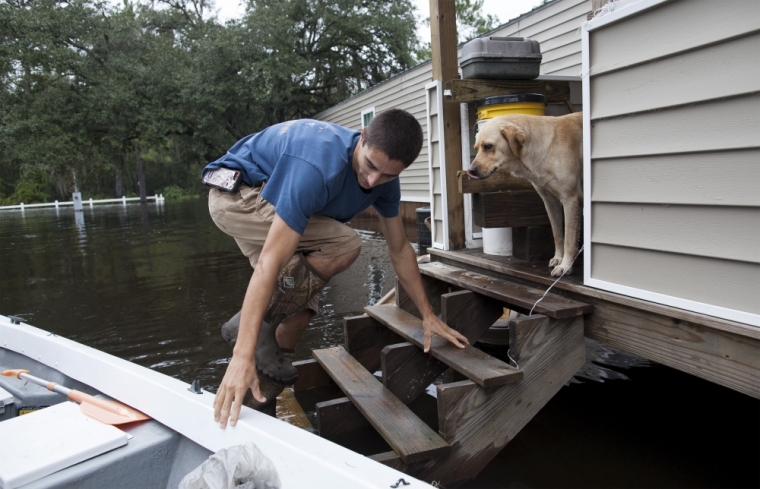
0,315 -> 432,489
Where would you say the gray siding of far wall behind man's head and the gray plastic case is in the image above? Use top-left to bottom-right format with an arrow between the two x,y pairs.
316,0 -> 591,203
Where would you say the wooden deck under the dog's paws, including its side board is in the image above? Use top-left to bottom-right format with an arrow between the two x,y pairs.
429,248 -> 760,398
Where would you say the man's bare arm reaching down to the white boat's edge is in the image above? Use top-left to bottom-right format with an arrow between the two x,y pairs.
214,216 -> 301,428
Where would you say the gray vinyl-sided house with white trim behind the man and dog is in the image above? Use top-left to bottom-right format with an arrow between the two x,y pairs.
318,0 -> 760,398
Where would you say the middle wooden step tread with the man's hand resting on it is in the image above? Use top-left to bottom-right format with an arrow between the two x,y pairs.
364,304 -> 523,387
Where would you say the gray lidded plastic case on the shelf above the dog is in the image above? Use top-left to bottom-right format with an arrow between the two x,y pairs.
459,37 -> 542,80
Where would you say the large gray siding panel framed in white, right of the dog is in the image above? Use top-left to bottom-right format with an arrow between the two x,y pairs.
587,0 -> 760,314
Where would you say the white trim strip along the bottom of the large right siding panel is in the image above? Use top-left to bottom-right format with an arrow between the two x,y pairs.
584,278 -> 760,327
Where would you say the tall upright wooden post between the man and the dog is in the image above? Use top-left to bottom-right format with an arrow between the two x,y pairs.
430,0 -> 465,250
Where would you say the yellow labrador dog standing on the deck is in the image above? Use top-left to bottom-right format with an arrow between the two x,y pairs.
467,112 -> 583,277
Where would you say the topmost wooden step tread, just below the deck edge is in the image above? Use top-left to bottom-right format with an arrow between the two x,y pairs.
420,262 -> 593,319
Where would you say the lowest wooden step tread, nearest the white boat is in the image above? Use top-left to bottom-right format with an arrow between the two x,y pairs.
312,346 -> 451,464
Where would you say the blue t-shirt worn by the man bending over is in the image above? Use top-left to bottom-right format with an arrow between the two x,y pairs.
203,119 -> 401,234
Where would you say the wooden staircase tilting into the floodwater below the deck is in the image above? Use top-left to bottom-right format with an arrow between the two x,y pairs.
294,255 -> 591,487
